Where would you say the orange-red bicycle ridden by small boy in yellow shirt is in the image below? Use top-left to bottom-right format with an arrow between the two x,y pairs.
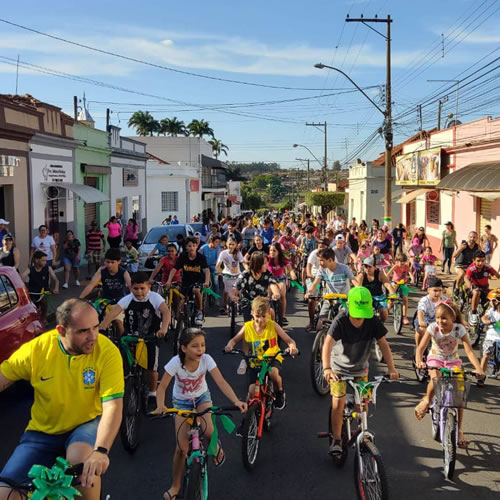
223,349 -> 296,470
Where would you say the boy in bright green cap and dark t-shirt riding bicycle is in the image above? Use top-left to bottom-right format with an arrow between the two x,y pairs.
322,286 -> 399,456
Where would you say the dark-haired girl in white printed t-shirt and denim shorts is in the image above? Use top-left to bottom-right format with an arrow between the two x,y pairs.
154,328 -> 247,500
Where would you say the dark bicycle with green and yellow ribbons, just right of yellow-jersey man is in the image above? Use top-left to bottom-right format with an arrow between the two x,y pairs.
112,335 -> 157,453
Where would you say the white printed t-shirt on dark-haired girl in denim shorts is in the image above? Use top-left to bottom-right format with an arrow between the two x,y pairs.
165,354 -> 217,400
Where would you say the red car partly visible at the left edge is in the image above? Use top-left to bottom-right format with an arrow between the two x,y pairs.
0,266 -> 43,363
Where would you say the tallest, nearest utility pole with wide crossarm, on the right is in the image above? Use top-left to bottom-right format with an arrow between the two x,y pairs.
346,15 -> 393,226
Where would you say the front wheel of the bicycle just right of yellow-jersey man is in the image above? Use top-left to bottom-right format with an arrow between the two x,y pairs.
120,375 -> 142,453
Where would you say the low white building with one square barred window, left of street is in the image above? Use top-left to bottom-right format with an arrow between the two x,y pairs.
146,153 -> 201,228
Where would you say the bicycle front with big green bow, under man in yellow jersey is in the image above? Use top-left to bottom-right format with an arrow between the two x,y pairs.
0,457 -> 83,500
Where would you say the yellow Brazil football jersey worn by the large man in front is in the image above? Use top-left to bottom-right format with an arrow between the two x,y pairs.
0,330 -> 124,434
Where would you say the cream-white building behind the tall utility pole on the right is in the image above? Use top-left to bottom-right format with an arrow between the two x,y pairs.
348,160 -> 401,224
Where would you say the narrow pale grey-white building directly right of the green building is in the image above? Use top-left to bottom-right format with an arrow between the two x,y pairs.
108,125 -> 146,234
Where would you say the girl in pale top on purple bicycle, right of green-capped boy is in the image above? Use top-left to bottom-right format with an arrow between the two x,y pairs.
415,299 -> 484,448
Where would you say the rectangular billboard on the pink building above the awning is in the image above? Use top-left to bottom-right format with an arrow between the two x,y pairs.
396,148 -> 441,186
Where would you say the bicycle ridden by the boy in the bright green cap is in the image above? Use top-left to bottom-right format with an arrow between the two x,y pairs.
318,376 -> 391,500
